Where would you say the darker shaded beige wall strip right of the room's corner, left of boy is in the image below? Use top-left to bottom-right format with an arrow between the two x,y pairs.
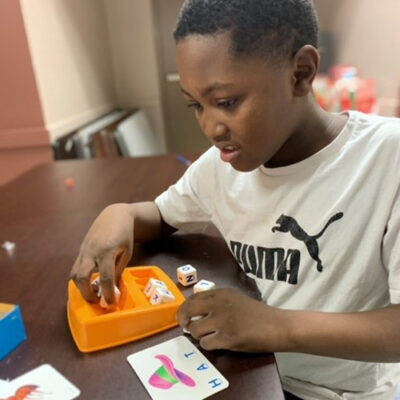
103,0 -> 167,148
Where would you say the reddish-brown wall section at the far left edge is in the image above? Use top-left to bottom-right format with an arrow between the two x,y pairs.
0,0 -> 52,185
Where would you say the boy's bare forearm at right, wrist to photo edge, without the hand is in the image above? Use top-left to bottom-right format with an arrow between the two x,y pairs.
282,304 -> 400,362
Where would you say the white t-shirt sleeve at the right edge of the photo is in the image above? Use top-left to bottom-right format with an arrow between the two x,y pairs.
383,187 -> 400,304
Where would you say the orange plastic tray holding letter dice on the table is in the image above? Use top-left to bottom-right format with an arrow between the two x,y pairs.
67,266 -> 185,352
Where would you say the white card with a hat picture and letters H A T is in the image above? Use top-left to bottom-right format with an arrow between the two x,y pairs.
128,336 -> 229,400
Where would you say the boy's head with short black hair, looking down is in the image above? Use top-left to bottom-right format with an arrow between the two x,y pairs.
174,0 -> 319,171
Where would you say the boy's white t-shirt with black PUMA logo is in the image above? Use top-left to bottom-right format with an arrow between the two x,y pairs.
156,112 -> 400,400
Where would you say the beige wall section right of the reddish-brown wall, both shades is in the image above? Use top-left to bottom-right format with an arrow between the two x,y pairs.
21,0 -> 164,148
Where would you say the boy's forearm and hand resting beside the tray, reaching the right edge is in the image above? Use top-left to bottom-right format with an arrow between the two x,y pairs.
178,289 -> 400,362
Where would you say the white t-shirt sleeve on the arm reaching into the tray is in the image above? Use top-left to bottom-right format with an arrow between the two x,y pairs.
155,149 -> 215,233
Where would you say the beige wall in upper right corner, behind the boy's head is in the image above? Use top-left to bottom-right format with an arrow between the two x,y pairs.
314,0 -> 400,115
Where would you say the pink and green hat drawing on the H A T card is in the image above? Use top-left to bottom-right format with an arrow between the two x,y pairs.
149,354 -> 196,389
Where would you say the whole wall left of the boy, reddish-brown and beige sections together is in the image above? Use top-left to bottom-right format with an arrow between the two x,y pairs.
0,0 -> 165,185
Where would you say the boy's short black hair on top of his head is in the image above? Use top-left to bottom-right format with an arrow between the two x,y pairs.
174,0 -> 319,62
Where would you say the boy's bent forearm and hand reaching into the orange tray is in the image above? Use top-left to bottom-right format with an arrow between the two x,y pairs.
71,202 -> 174,304
